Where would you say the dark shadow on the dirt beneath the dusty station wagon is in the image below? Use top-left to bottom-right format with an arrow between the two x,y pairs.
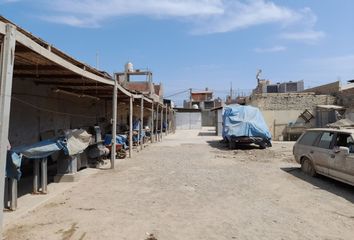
280,167 -> 354,204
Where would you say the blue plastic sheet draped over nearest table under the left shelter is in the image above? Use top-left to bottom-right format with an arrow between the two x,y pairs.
11,139 -> 68,159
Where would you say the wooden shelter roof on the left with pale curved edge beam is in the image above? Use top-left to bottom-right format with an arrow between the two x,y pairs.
0,16 -> 156,102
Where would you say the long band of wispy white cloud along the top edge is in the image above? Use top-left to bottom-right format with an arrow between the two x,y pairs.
38,0 -> 324,39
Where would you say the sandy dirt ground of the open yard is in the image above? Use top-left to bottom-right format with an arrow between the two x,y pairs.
5,128 -> 354,240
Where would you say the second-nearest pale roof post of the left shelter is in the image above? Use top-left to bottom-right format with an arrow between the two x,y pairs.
111,79 -> 118,169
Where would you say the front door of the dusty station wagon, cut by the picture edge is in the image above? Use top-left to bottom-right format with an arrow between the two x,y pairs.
329,133 -> 354,185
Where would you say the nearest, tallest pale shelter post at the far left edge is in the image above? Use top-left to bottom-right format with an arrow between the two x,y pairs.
0,24 -> 16,231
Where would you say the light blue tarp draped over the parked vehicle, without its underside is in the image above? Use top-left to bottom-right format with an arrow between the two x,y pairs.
222,105 -> 272,140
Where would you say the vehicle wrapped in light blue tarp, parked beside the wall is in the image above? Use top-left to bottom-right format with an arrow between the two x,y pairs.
222,104 -> 272,148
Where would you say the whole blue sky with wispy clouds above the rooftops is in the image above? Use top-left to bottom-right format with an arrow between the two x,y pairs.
0,0 -> 354,105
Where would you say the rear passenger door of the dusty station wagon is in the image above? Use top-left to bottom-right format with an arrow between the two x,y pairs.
310,131 -> 334,175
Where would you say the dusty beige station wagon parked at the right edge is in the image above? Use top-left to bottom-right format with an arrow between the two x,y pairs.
293,128 -> 354,186
